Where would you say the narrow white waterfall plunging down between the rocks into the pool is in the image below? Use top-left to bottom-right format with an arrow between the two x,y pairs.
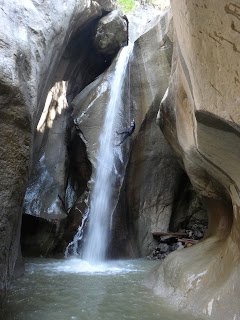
83,44 -> 133,263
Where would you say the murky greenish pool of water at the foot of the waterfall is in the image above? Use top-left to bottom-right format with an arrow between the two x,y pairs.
4,258 -> 201,320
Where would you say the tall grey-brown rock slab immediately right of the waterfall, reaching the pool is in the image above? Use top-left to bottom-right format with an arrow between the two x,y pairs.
109,11 -> 186,257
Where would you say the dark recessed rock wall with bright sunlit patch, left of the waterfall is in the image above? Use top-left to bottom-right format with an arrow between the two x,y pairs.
24,5 -> 119,224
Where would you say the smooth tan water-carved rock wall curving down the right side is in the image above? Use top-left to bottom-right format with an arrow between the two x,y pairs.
146,0 -> 240,320
